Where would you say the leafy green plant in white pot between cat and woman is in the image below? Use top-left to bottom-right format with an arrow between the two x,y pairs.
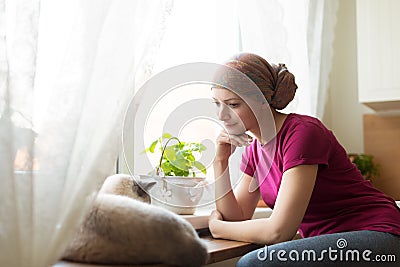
141,133 -> 207,214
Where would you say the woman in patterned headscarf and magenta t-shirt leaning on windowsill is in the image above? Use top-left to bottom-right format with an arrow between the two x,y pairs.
209,54 -> 400,266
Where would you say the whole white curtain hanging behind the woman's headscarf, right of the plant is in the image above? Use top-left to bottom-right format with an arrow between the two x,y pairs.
238,0 -> 338,118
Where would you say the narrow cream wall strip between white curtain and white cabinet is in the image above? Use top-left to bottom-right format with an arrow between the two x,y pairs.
323,0 -> 372,153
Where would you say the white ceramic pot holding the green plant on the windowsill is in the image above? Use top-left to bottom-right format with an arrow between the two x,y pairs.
138,175 -> 205,215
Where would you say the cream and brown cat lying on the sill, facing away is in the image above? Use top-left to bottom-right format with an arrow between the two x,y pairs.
63,174 -> 207,267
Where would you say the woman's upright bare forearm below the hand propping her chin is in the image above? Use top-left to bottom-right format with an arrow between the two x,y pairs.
213,160 -> 248,221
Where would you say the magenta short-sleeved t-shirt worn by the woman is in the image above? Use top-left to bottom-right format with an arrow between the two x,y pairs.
240,114 -> 400,237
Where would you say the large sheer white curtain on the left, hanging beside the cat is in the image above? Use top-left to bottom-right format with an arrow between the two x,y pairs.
0,0 -> 172,267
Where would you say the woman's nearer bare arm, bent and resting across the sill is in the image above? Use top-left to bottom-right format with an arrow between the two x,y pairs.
209,165 -> 318,244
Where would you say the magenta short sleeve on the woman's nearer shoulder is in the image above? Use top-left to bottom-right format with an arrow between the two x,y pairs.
282,122 -> 332,171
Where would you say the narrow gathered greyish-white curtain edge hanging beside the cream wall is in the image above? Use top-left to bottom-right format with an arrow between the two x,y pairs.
307,0 -> 339,119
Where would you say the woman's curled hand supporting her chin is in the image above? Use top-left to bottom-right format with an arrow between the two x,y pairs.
215,130 -> 253,161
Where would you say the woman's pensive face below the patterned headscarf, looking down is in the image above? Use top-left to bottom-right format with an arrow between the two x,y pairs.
212,87 -> 262,135
